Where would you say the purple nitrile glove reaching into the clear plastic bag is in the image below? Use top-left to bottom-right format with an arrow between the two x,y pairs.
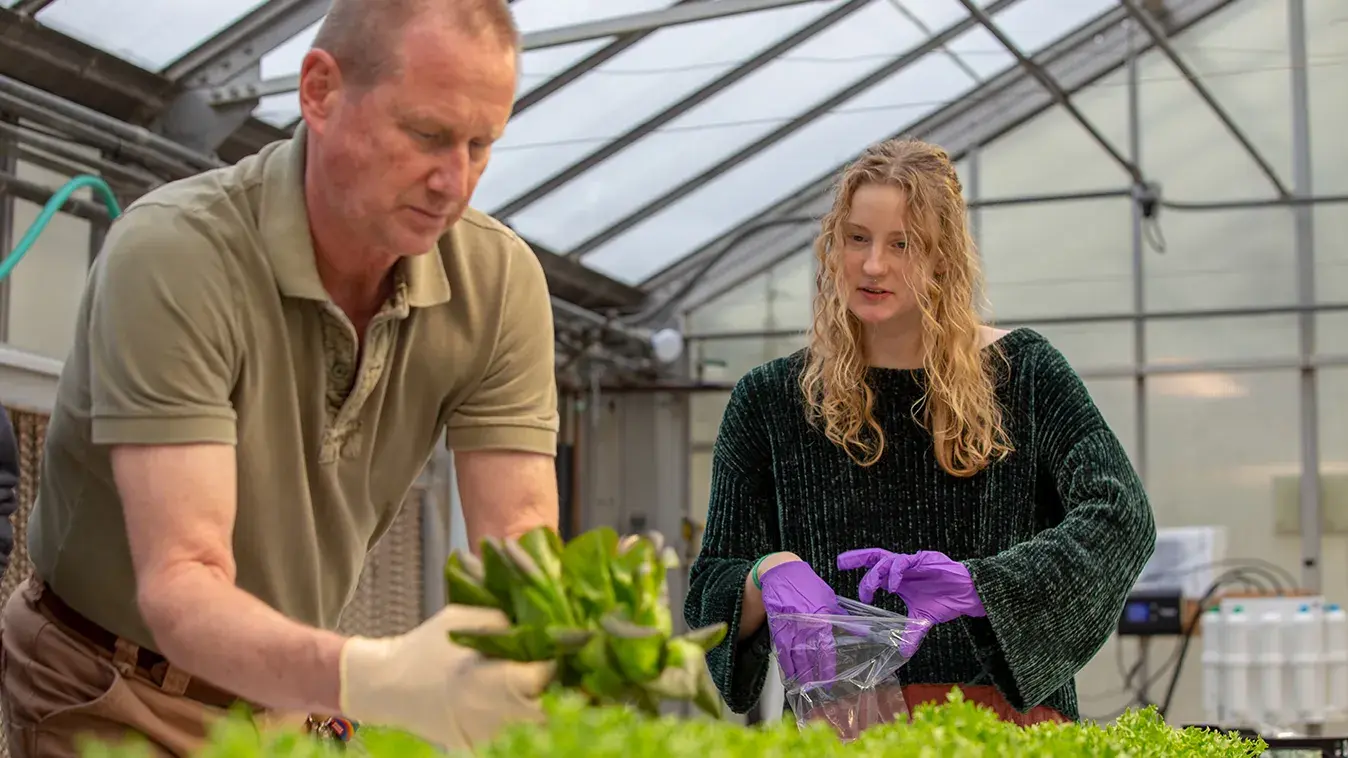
759,561 -> 847,684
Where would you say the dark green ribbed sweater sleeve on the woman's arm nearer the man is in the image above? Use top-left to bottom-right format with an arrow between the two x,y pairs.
683,370 -> 782,713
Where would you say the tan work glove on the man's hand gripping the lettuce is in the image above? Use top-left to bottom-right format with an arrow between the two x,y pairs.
341,606 -> 554,750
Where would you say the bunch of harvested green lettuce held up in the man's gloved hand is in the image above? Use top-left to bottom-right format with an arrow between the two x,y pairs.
445,527 -> 727,718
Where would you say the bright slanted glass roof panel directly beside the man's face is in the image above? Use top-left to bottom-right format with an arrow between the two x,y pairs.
473,0 -> 843,212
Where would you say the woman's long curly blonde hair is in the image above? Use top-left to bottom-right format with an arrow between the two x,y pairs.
799,139 -> 1012,476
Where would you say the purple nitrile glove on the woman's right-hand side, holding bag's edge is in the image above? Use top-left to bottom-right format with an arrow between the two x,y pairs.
838,548 -> 987,658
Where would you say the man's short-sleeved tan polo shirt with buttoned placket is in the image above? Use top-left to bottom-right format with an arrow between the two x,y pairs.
28,125 -> 558,649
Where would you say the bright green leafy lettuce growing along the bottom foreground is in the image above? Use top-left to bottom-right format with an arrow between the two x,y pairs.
84,692 -> 1267,758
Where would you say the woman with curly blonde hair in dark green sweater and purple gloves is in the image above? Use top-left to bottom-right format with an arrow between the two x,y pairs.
685,140 -> 1155,723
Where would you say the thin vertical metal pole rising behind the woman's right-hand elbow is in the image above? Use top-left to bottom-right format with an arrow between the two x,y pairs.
1127,22 -> 1148,484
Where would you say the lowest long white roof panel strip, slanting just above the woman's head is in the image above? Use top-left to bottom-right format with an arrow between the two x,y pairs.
574,0 -> 1112,283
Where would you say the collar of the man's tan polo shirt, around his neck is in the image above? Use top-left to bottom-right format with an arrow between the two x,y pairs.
257,123 -> 450,308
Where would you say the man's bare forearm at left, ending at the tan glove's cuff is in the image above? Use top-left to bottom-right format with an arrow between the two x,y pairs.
140,564 -> 345,713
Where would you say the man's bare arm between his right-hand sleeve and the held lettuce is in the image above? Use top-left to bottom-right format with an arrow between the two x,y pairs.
454,450 -> 558,553
